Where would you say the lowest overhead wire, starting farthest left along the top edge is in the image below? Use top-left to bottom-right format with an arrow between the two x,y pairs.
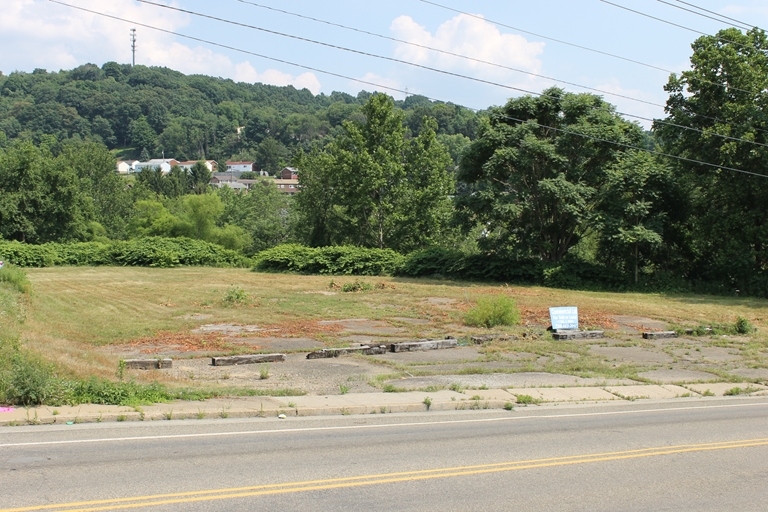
48,0 -> 768,178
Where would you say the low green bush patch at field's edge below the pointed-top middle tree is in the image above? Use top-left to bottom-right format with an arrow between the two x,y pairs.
254,244 -> 404,276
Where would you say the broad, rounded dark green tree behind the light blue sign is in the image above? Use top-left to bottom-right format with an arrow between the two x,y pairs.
456,88 -> 642,261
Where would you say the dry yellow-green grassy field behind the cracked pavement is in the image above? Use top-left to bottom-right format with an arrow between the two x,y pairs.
6,267 -> 768,392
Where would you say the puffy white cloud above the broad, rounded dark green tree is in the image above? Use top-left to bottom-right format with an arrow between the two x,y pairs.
390,14 -> 544,80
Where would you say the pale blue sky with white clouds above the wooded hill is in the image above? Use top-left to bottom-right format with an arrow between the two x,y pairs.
0,0 -> 768,127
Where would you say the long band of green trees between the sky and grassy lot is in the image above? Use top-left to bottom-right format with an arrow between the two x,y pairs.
0,29 -> 768,296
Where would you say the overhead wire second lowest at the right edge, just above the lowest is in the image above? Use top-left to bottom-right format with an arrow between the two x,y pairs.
136,0 -> 768,151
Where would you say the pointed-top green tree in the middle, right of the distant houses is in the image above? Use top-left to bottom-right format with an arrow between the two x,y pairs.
295,94 -> 453,251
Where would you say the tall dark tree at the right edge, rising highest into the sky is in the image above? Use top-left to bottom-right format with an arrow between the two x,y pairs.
654,29 -> 768,294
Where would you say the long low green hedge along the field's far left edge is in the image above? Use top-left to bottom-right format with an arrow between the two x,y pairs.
0,237 -> 251,267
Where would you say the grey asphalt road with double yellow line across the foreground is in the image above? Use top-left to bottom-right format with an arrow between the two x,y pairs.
0,397 -> 768,512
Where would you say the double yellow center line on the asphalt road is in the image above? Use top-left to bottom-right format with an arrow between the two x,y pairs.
6,438 -> 768,512
